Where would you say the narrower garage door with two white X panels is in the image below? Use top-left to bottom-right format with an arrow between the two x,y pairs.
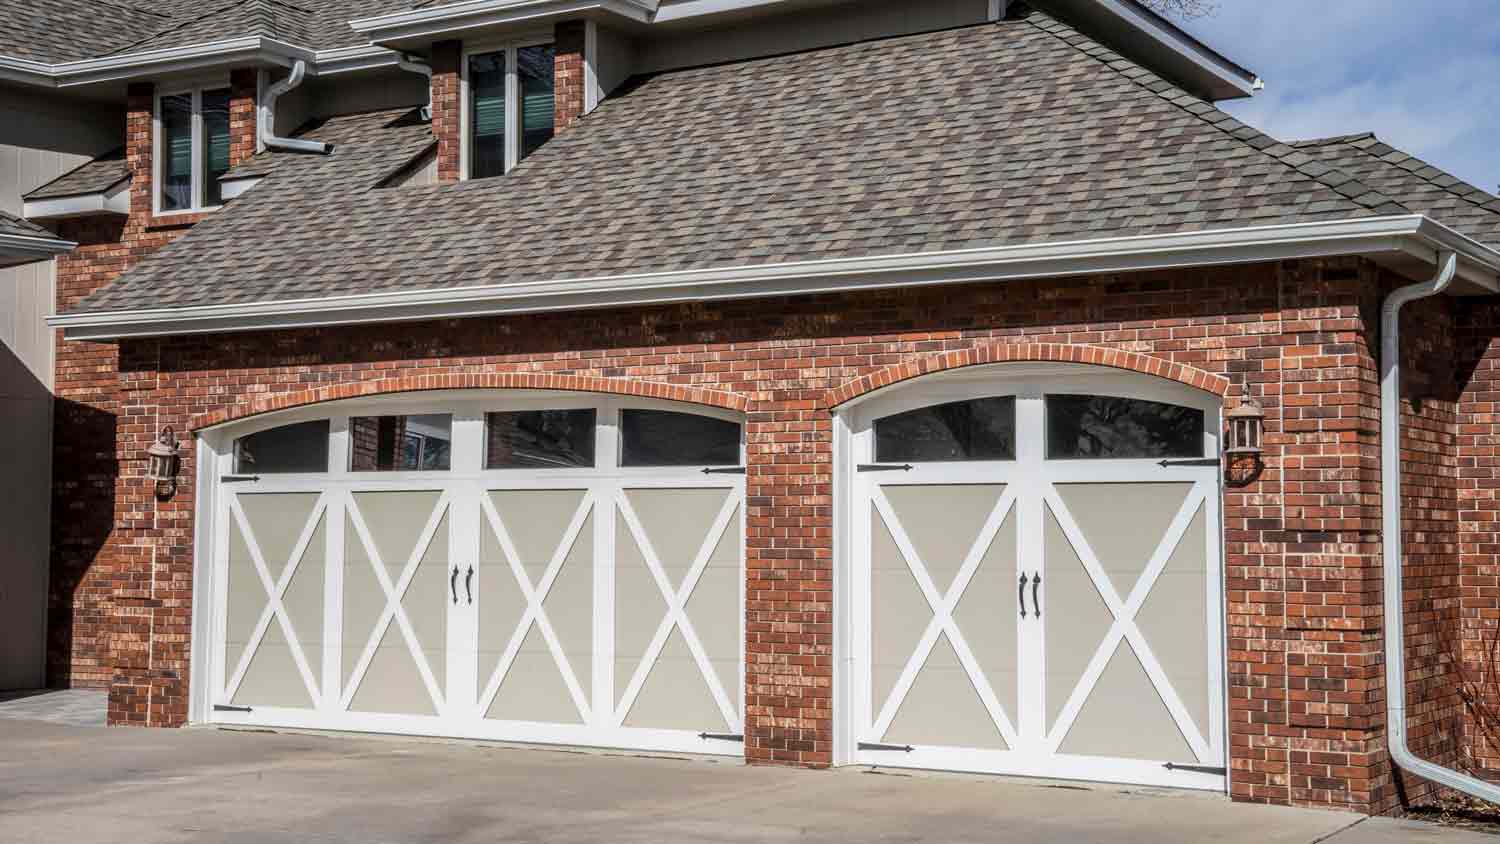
845,364 -> 1224,789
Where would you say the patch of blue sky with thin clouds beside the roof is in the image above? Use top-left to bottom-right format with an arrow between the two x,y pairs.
1182,0 -> 1500,193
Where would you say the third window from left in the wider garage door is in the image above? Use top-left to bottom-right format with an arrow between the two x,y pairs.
485,408 -> 599,469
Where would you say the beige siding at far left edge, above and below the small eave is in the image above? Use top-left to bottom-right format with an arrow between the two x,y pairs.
0,88 -> 125,690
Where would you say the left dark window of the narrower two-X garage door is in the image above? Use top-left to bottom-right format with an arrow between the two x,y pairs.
875,396 -> 1016,463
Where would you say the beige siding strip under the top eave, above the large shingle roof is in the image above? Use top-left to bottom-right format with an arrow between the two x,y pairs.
636,0 -> 990,72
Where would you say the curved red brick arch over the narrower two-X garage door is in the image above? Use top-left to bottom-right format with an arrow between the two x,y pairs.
822,343 -> 1230,408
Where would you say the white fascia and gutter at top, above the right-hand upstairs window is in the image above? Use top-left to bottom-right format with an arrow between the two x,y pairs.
350,0 -> 656,43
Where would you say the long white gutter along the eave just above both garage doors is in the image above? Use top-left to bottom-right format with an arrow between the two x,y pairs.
48,214 -> 1500,340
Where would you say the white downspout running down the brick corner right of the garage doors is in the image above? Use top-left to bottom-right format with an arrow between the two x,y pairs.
1380,252 -> 1500,802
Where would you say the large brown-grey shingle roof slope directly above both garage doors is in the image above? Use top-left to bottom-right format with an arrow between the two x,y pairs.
75,12 -> 1409,312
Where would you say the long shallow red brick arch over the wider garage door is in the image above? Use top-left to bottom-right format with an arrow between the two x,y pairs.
192,372 -> 750,430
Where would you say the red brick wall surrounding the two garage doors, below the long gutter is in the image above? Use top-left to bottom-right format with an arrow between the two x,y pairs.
85,259 -> 1452,811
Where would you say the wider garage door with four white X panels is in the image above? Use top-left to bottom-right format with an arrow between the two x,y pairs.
203,394 -> 744,754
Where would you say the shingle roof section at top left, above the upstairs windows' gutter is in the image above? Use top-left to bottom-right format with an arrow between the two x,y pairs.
0,0 -> 411,63
